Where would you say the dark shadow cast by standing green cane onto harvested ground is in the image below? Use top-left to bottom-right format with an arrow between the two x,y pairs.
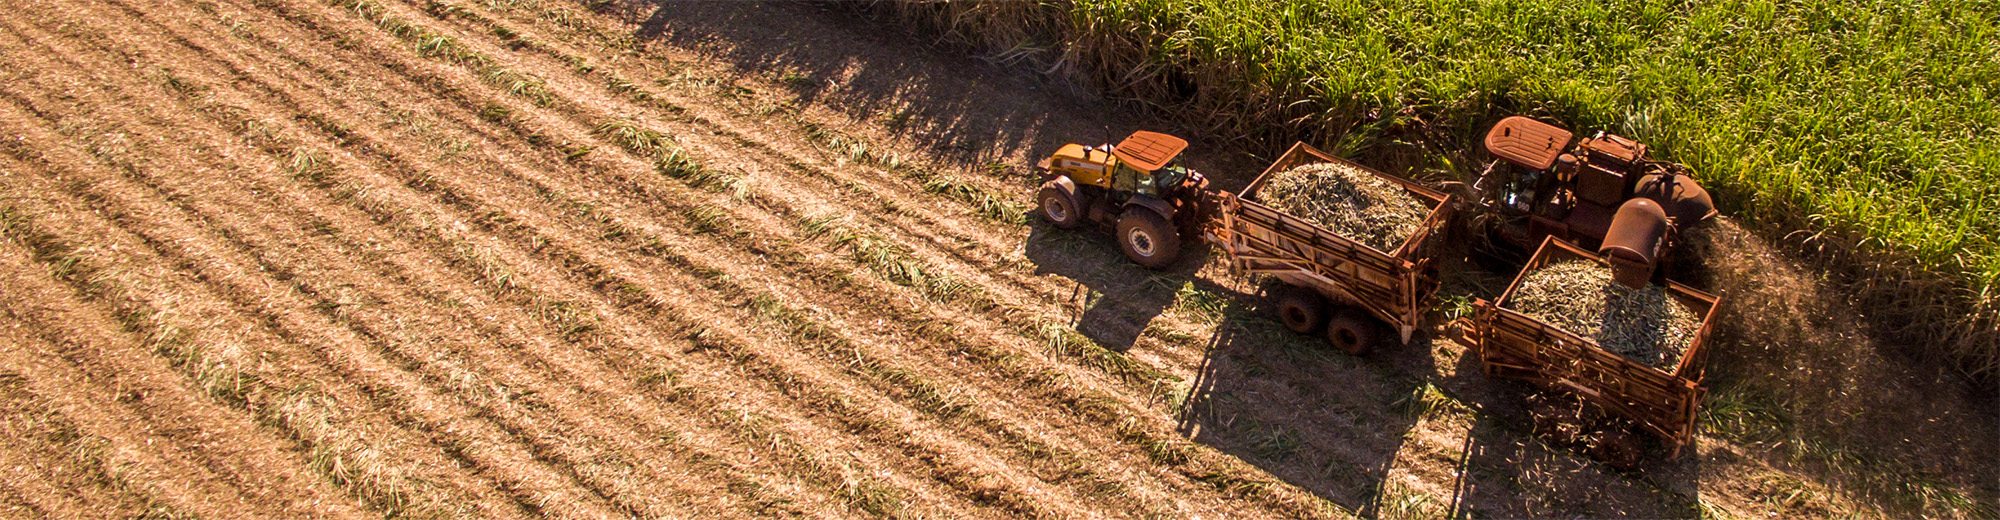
626,0 -> 1160,170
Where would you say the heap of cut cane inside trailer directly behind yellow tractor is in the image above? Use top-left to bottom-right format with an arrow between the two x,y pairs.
1258,162 -> 1430,252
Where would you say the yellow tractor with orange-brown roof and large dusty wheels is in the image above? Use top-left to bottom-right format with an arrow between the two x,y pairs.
1034,132 -> 1208,268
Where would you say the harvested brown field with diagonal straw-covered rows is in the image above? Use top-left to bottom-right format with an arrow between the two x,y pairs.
0,0 -> 1994,518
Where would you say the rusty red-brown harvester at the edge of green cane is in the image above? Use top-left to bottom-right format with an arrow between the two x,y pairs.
1474,116 -> 1716,286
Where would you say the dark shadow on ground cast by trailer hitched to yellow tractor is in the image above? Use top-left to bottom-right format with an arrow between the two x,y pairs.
1176,290 -> 1444,518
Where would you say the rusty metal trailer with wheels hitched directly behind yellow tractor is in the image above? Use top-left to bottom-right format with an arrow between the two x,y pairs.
1204,142 -> 1454,354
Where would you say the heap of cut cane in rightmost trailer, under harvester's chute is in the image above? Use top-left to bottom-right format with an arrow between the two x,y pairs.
1508,260 -> 1702,370
